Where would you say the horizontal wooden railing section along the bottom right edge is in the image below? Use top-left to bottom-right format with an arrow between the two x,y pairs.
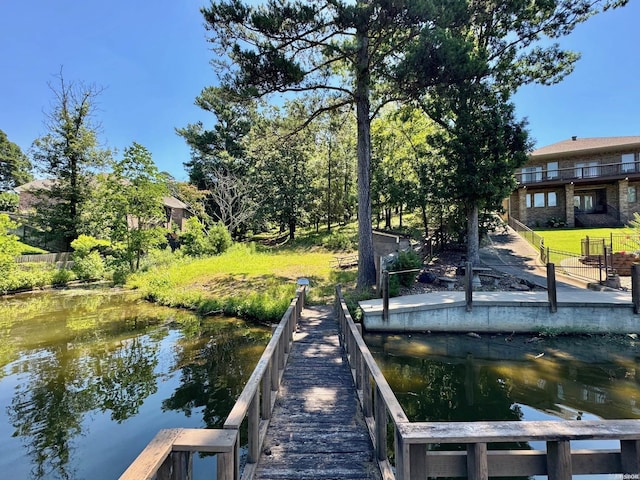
396,420 -> 640,480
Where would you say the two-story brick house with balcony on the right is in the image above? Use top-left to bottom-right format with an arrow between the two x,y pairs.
507,136 -> 640,227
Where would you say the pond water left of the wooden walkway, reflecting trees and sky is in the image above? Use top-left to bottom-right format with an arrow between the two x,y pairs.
0,290 -> 271,480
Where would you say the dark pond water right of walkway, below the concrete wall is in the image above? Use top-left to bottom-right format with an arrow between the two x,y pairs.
365,334 -> 640,479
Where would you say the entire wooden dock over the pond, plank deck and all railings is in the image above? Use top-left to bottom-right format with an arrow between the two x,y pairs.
120,285 -> 640,480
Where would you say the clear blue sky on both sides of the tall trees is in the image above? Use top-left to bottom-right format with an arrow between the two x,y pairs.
0,0 -> 640,180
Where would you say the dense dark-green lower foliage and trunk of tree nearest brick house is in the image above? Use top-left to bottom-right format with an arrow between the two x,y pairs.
431,85 -> 531,264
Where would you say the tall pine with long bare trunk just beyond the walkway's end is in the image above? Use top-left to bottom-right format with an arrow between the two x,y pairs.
202,0 -> 444,288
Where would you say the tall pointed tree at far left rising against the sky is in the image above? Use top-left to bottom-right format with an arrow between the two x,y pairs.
33,74 -> 110,248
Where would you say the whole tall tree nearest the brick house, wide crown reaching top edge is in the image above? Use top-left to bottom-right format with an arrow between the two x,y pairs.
394,0 -> 627,262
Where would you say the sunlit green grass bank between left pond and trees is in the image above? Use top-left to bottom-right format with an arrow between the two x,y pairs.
127,229 -> 364,321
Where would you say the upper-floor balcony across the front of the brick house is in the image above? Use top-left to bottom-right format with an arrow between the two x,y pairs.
515,162 -> 640,187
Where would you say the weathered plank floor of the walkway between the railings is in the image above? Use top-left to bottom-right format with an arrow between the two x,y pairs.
254,306 -> 380,480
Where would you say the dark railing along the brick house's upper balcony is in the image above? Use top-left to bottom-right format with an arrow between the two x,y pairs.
515,162 -> 640,185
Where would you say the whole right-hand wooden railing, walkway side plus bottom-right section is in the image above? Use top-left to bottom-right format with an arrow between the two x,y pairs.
336,286 -> 640,480
